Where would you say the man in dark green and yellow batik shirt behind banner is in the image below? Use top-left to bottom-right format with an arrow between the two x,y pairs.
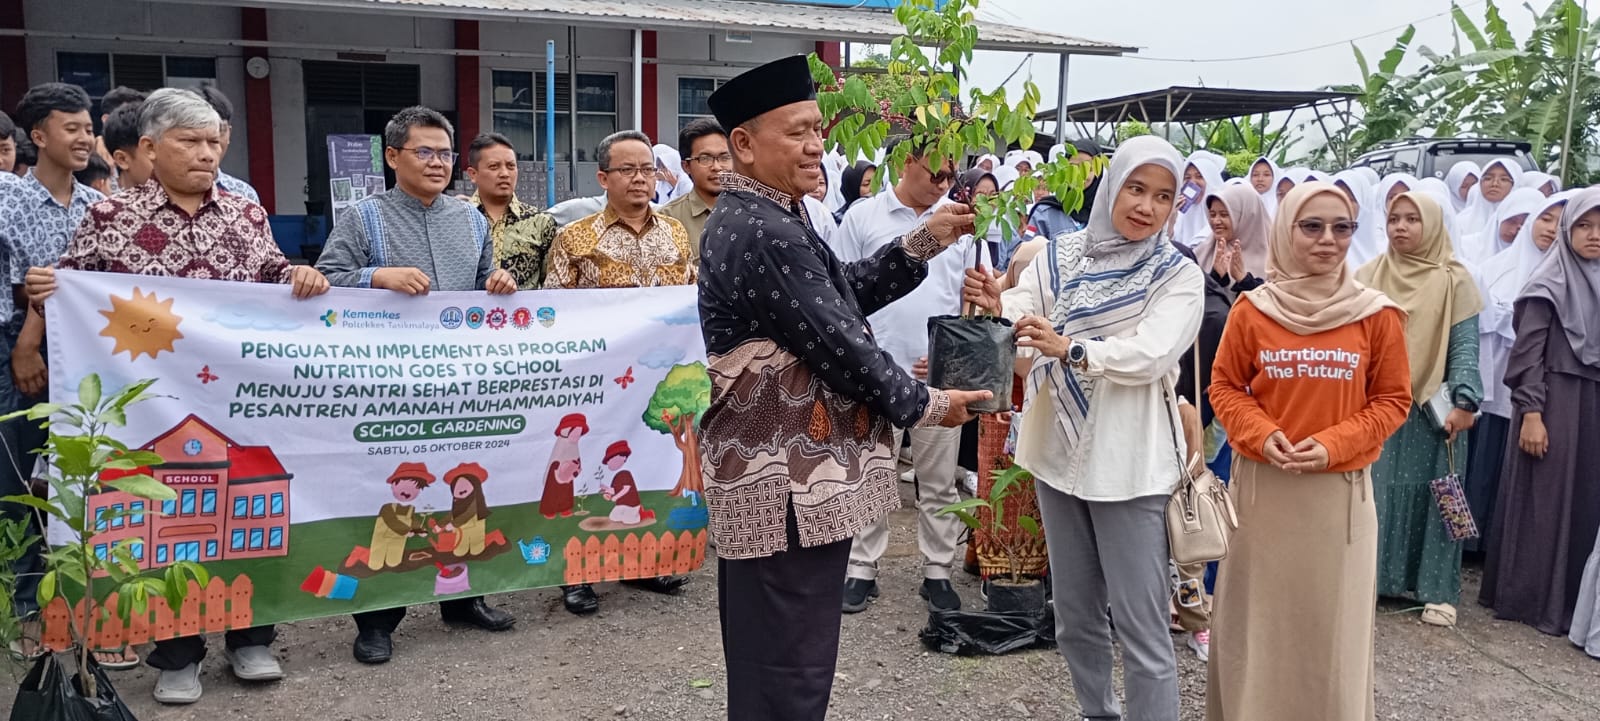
467,133 -> 557,291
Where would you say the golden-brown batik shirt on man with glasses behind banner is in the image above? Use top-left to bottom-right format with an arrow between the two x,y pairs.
544,206 -> 699,288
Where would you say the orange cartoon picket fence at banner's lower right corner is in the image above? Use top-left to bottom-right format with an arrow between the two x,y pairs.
563,529 -> 706,585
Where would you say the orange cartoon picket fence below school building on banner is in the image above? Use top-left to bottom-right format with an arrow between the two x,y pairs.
43,576 -> 256,651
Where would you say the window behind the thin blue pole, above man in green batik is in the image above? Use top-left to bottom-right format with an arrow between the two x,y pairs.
491,70 -> 618,163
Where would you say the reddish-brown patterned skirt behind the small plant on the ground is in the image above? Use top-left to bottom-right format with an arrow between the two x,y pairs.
973,384 -> 1050,579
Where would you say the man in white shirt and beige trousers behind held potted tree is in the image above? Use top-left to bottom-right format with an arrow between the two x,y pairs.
834,134 -> 974,614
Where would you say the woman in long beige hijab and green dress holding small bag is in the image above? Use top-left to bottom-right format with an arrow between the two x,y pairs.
1355,192 -> 1483,627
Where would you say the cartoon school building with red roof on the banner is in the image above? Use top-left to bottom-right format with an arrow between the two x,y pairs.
88,416 -> 293,569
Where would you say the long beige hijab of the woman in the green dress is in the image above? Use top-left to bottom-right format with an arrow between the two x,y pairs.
1355,192 -> 1483,398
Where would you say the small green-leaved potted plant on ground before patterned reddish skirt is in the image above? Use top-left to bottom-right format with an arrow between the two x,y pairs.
939,464 -> 1045,612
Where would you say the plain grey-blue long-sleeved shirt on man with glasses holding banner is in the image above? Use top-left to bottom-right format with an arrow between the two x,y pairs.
317,187 -> 494,291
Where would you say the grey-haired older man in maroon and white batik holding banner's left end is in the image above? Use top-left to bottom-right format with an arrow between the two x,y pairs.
27,88 -> 328,703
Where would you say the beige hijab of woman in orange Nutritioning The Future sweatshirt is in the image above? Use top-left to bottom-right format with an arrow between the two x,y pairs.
1245,181 -> 1398,336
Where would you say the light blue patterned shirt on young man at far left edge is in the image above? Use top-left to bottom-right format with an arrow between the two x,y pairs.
0,171 -> 106,341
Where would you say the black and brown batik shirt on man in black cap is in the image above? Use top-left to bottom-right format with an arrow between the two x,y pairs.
699,174 -> 949,558
